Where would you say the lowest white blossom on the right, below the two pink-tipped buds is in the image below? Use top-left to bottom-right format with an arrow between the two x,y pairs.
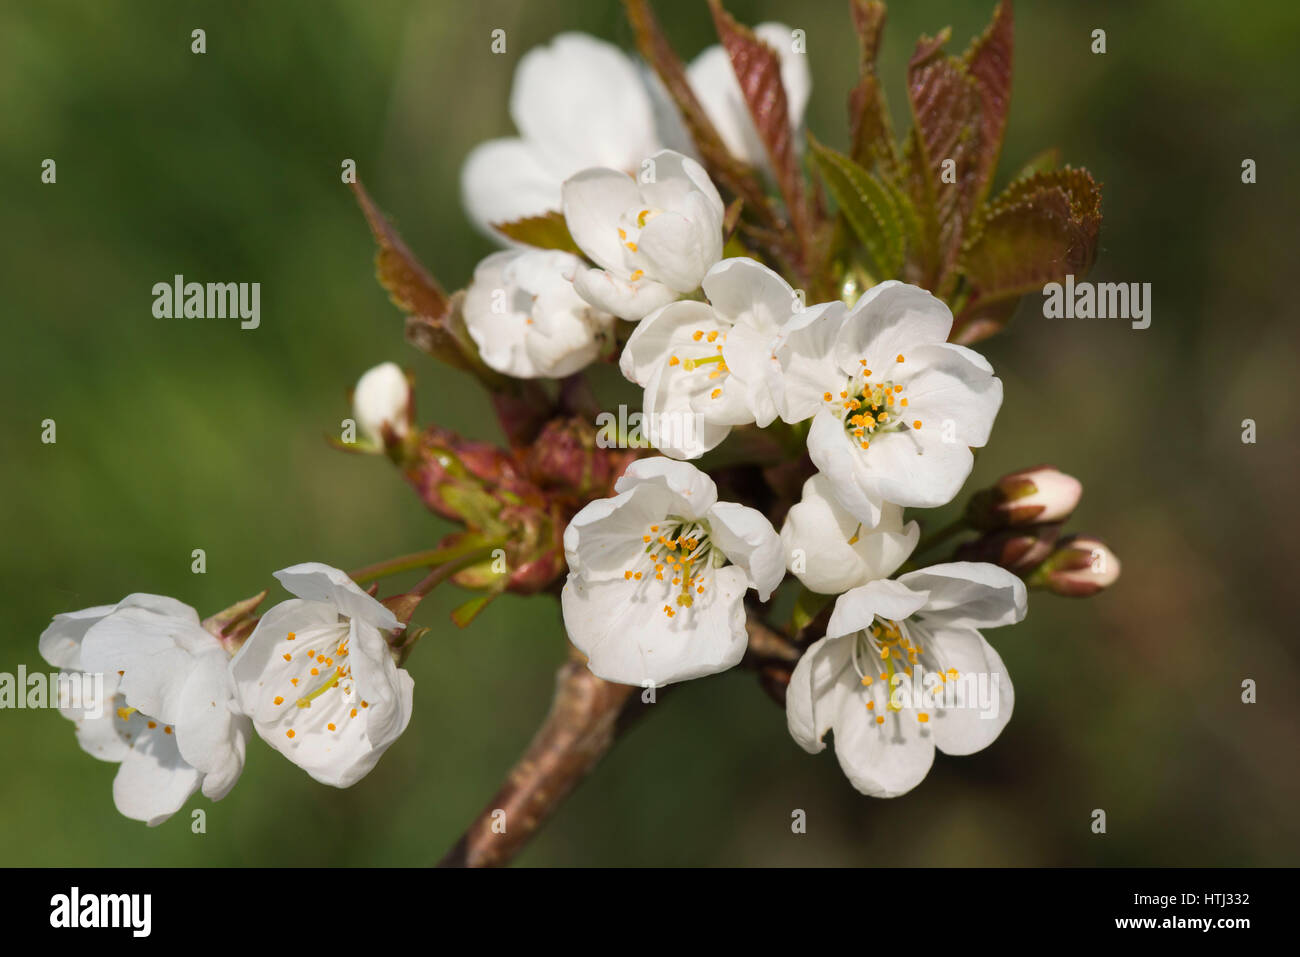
785,562 -> 1026,797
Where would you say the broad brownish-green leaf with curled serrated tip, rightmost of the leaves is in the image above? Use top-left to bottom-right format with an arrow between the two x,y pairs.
952,168 -> 1101,343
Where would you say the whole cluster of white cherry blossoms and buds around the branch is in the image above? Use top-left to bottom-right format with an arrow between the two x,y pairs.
40,3 -> 1119,824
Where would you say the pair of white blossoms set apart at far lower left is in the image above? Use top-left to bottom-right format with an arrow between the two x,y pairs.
40,563 -> 413,826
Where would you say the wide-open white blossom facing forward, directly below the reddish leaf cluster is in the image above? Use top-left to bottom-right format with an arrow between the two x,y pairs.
768,280 -> 1002,527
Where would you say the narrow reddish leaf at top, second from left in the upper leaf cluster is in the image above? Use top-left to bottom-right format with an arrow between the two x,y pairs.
709,0 -> 816,264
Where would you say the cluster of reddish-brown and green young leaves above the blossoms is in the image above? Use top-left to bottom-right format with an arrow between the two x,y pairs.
625,0 -> 1101,342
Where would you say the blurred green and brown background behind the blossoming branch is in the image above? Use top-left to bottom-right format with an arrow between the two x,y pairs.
0,0 -> 1300,866
